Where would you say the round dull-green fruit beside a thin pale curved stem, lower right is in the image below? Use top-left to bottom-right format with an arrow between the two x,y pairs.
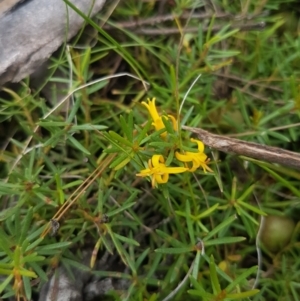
260,215 -> 295,253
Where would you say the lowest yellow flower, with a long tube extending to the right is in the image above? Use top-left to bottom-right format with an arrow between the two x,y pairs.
136,155 -> 188,187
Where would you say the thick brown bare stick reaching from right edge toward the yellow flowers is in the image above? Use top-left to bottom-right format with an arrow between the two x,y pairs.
182,126 -> 300,170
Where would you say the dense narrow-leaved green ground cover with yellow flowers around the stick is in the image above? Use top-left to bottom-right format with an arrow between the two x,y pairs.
0,0 -> 300,301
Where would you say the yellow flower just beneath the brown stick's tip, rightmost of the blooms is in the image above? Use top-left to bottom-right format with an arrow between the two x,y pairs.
175,138 -> 213,172
